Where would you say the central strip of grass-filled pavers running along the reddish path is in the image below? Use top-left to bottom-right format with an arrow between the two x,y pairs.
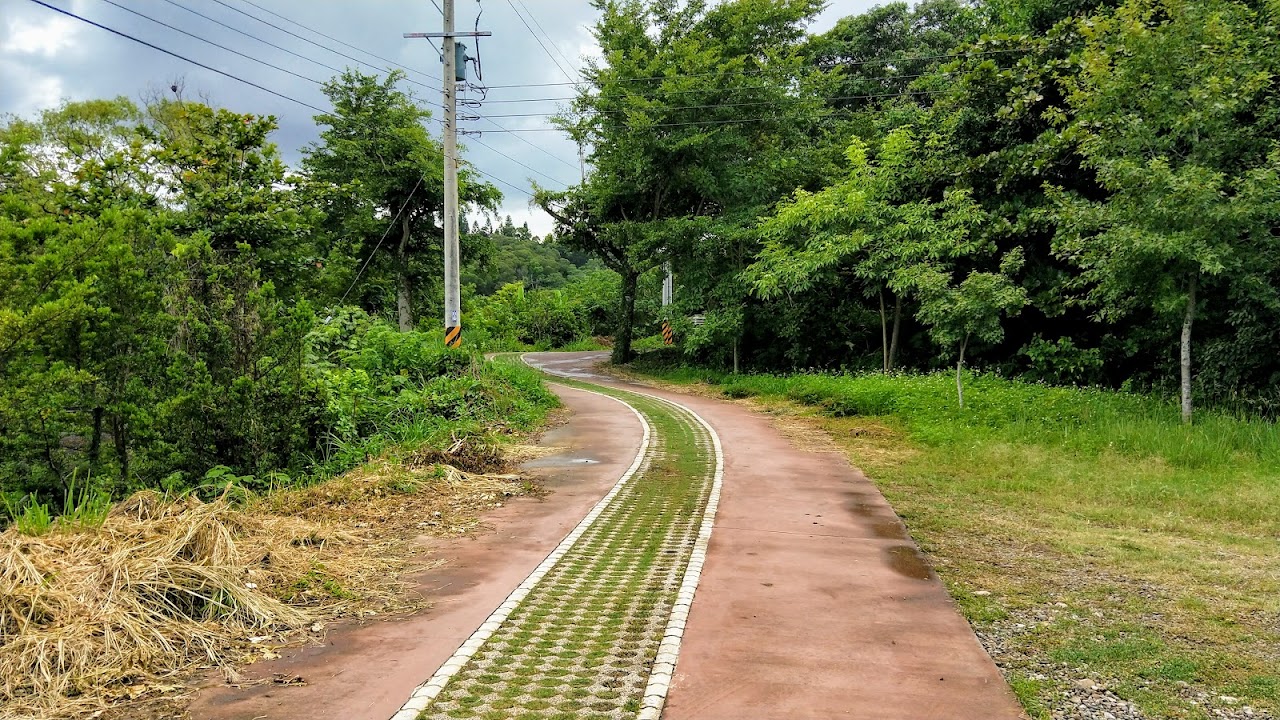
419,376 -> 714,720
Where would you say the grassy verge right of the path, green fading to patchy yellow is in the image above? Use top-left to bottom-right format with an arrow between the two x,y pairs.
632,360 -> 1280,719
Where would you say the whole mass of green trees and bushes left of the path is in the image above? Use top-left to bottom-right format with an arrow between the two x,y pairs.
0,79 -> 563,514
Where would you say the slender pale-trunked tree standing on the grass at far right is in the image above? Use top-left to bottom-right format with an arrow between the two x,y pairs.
1056,0 -> 1280,423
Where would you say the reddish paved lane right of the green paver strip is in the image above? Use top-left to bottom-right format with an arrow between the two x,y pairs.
526,354 -> 1025,720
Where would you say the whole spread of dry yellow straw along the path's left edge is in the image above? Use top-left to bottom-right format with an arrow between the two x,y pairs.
0,450 -> 531,720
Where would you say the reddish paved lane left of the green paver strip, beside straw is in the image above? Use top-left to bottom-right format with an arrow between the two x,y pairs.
189,387 -> 643,720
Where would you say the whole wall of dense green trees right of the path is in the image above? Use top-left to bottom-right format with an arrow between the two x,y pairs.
539,0 -> 1280,419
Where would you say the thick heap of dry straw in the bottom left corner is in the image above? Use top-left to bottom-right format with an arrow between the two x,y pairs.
0,492 -> 311,716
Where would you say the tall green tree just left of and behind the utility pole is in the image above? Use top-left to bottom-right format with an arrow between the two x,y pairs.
302,70 -> 500,332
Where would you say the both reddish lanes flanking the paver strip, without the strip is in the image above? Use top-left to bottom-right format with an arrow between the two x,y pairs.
191,354 -> 1025,720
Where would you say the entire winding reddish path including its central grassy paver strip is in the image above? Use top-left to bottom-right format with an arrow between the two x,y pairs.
192,354 -> 1024,720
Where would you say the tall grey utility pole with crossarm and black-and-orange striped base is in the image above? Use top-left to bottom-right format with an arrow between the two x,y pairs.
404,0 -> 493,347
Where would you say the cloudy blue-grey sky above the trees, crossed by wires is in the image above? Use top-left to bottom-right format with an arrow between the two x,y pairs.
0,0 -> 877,233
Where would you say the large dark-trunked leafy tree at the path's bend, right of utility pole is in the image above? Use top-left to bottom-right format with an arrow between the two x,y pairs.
538,0 -> 822,361
